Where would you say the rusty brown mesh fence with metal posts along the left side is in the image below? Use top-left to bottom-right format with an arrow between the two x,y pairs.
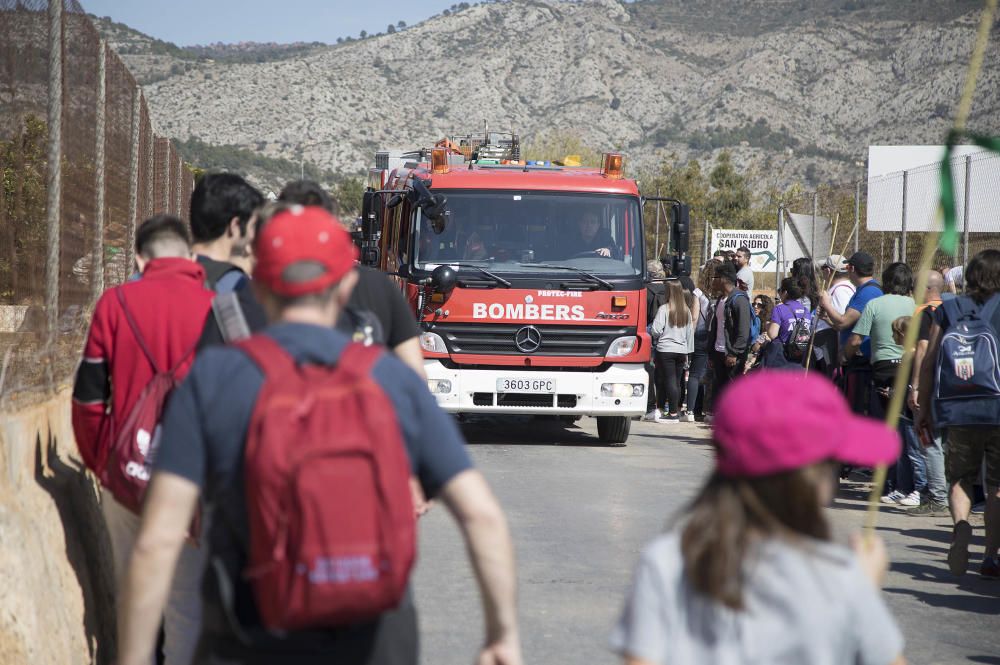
0,0 -> 194,407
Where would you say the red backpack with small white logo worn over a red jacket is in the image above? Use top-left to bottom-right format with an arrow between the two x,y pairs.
98,287 -> 198,513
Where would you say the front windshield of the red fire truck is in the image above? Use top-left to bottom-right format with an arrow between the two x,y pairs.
414,190 -> 643,276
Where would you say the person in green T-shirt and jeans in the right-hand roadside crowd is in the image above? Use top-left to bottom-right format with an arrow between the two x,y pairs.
843,262 -> 927,507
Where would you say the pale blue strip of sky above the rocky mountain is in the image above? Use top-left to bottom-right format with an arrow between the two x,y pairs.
81,0 -> 473,46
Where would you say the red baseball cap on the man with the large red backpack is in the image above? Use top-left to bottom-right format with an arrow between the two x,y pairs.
253,206 -> 358,297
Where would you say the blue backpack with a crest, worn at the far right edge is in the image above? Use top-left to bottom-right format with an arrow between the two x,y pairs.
934,295 -> 1000,427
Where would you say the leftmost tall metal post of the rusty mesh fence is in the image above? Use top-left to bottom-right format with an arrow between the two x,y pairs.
45,1 -> 63,378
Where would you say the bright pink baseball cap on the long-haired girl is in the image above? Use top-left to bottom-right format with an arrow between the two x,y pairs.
712,370 -> 900,478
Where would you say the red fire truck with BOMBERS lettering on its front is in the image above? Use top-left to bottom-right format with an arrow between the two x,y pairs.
361,133 -> 680,443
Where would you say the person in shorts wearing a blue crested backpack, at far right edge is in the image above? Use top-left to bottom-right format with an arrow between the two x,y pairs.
917,249 -> 1000,578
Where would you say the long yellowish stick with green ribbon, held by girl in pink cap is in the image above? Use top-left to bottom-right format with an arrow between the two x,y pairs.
865,0 -> 997,538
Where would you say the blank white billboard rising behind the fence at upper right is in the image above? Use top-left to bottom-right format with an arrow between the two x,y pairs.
866,145 -> 1000,233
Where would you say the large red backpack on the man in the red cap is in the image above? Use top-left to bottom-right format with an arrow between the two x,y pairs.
235,335 -> 416,630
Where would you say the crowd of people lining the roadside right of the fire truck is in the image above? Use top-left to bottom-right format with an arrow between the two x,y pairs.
646,247 -> 1000,578
